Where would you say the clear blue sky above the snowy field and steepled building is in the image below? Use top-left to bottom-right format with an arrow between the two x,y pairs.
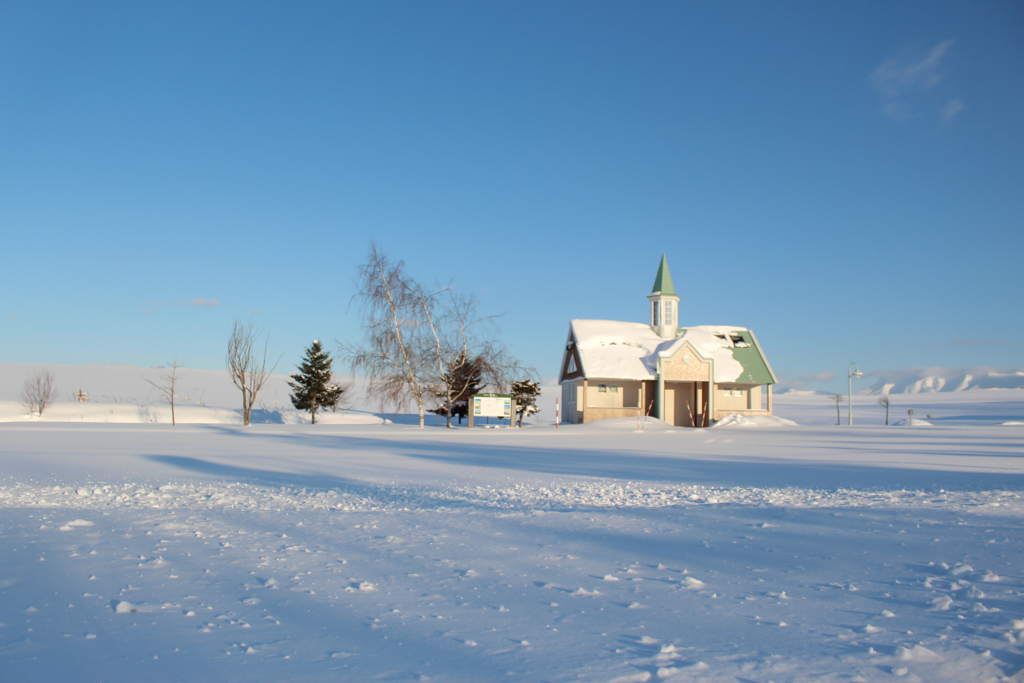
0,0 -> 1024,388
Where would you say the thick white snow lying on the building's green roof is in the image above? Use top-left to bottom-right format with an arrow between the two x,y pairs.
569,319 -> 753,383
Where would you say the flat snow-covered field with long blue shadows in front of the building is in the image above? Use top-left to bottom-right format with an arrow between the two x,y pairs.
0,370 -> 1024,683
